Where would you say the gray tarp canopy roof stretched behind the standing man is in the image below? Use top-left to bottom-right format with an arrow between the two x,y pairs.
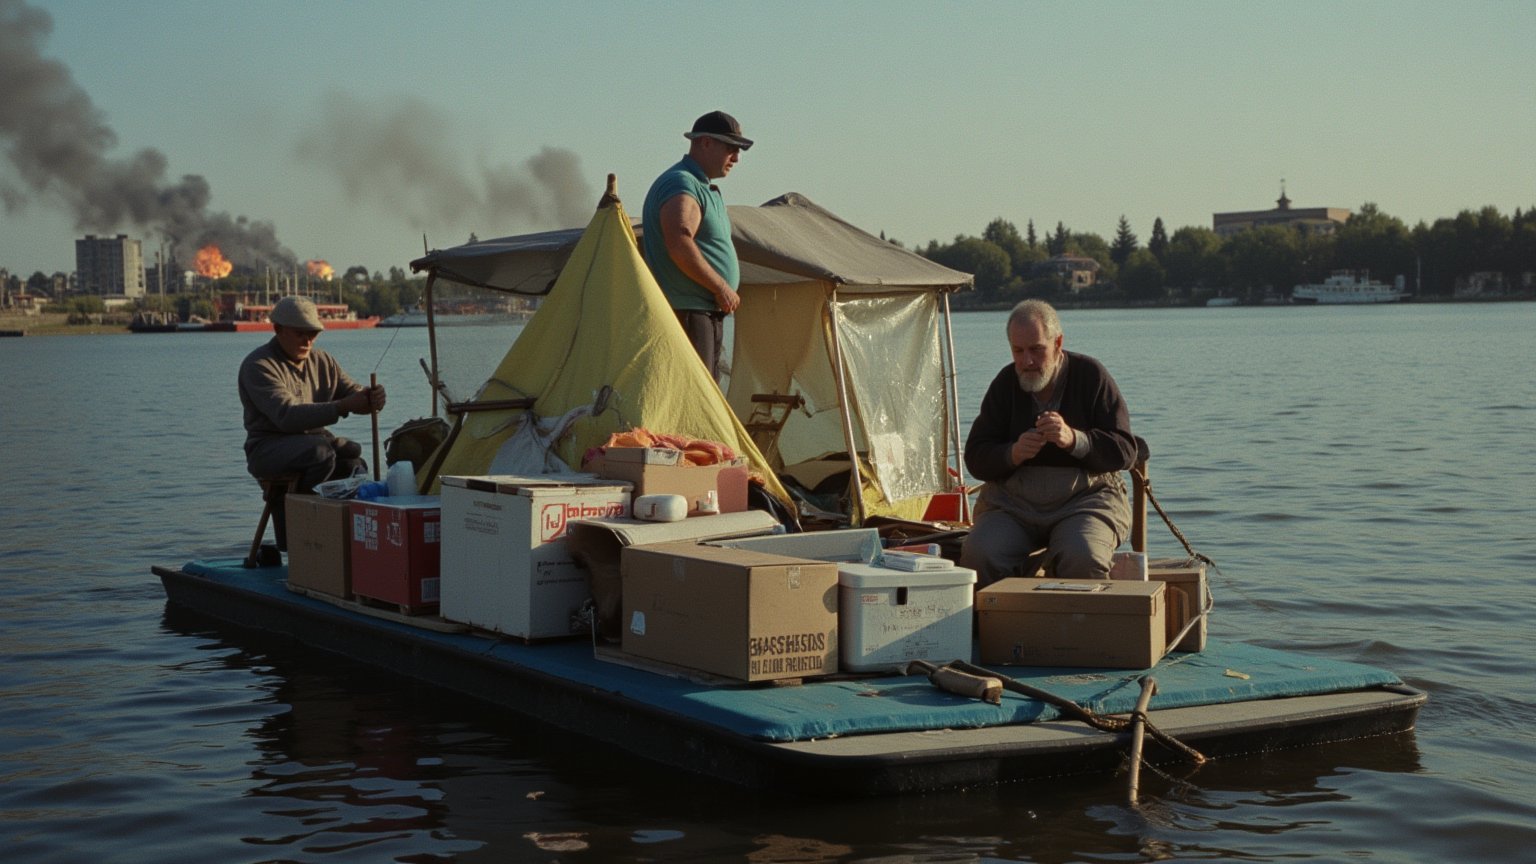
410,192 -> 974,294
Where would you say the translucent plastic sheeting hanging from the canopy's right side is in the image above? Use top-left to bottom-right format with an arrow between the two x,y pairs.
833,294 -> 949,503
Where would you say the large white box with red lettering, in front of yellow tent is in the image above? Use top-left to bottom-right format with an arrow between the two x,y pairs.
442,474 -> 630,640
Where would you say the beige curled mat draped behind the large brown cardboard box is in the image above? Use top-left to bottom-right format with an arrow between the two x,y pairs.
565,510 -> 779,643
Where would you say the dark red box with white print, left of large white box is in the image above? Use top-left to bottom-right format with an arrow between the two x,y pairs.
349,495 -> 442,615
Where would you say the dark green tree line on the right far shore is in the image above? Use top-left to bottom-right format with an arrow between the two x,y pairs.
915,203 -> 1536,307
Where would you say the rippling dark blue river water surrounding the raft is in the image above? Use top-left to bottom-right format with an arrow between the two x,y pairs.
0,303 -> 1536,864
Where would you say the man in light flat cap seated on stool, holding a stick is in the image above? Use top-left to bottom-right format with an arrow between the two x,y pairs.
240,297 -> 384,549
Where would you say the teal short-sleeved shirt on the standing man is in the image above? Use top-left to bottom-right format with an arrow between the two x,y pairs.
641,155 -> 742,312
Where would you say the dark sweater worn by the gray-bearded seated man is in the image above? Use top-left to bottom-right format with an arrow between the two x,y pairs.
965,351 -> 1137,481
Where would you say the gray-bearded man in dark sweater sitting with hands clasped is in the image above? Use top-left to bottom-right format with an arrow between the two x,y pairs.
960,300 -> 1137,587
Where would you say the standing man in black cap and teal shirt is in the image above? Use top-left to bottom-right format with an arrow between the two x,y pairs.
641,111 -> 753,383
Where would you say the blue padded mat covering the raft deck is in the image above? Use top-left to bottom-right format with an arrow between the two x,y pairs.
181,560 -> 1401,741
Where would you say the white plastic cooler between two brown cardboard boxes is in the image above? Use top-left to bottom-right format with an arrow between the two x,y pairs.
837,564 -> 975,672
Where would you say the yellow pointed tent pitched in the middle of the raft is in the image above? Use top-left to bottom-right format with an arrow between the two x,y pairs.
422,191 -> 791,507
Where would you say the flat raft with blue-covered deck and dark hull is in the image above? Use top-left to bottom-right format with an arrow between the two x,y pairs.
154,558 -> 1425,795
